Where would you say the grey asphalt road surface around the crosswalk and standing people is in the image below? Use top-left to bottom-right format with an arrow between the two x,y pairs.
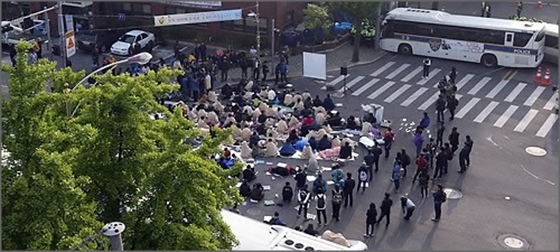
233,52 -> 558,250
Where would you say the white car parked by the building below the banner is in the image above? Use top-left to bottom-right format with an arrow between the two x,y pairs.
111,30 -> 156,56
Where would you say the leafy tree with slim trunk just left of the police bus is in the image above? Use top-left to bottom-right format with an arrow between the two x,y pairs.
329,2 -> 381,62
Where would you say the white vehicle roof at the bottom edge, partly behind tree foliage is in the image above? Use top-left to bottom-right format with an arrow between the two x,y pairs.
222,210 -> 353,251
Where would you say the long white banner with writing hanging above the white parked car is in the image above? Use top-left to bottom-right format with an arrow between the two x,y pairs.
154,9 -> 243,26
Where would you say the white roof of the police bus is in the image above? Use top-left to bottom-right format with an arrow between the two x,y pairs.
387,8 -> 544,33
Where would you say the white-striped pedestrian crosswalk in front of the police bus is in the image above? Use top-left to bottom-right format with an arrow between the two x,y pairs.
321,61 -> 558,138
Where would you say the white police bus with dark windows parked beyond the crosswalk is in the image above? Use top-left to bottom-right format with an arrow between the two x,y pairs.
380,8 -> 545,68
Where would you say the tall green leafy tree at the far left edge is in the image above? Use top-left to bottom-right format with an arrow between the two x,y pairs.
2,43 -> 103,250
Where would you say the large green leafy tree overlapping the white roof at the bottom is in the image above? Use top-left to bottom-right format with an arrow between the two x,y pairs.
72,66 -> 241,250
